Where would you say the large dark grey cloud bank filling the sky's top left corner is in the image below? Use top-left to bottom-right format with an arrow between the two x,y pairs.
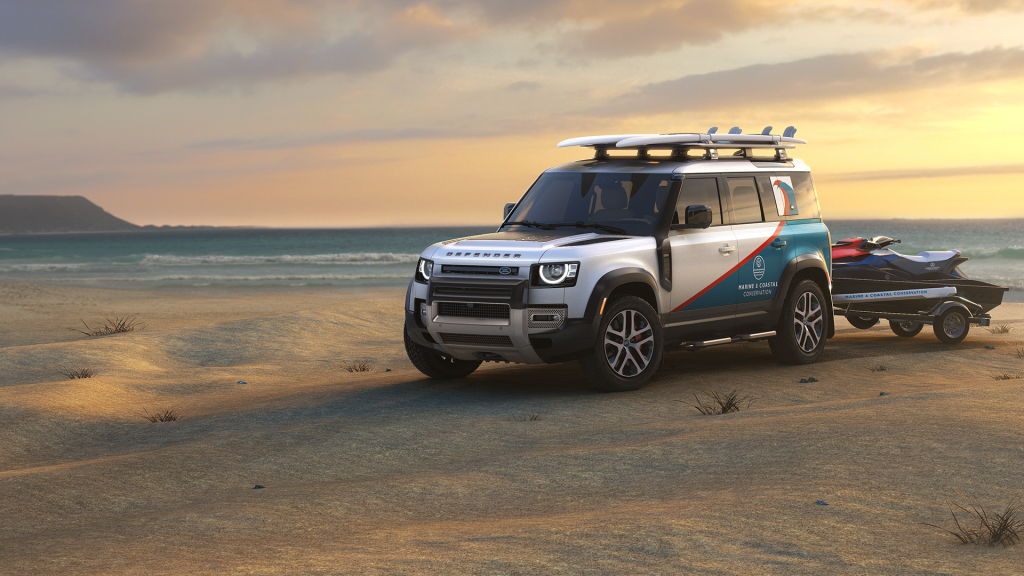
0,0 -> 471,93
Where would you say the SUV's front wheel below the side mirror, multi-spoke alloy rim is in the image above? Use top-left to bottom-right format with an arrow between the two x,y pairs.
580,296 -> 665,392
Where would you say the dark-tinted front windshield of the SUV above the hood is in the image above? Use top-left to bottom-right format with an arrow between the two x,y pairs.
503,172 -> 672,236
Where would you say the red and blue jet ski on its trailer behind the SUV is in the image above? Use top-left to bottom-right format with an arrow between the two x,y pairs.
831,236 -> 1009,343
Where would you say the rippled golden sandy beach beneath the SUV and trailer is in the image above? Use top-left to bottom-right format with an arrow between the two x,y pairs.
0,284 -> 1024,575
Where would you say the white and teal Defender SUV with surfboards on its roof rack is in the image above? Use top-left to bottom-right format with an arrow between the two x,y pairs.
404,126 -> 835,390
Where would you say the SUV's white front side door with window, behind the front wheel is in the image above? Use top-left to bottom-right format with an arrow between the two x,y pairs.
665,176 -> 737,331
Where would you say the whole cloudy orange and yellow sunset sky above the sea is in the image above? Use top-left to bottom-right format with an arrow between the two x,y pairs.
0,0 -> 1024,227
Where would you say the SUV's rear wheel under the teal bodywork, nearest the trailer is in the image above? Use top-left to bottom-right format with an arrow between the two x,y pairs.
768,280 -> 828,364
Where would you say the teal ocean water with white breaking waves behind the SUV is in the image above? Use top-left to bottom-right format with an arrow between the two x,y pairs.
0,219 -> 1024,301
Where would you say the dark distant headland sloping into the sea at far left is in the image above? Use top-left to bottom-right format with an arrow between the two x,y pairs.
0,194 -> 213,234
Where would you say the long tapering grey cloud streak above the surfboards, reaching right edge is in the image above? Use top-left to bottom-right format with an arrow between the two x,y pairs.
595,47 -> 1024,116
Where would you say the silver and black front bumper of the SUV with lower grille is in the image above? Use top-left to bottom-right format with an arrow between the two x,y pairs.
406,279 -> 597,364
